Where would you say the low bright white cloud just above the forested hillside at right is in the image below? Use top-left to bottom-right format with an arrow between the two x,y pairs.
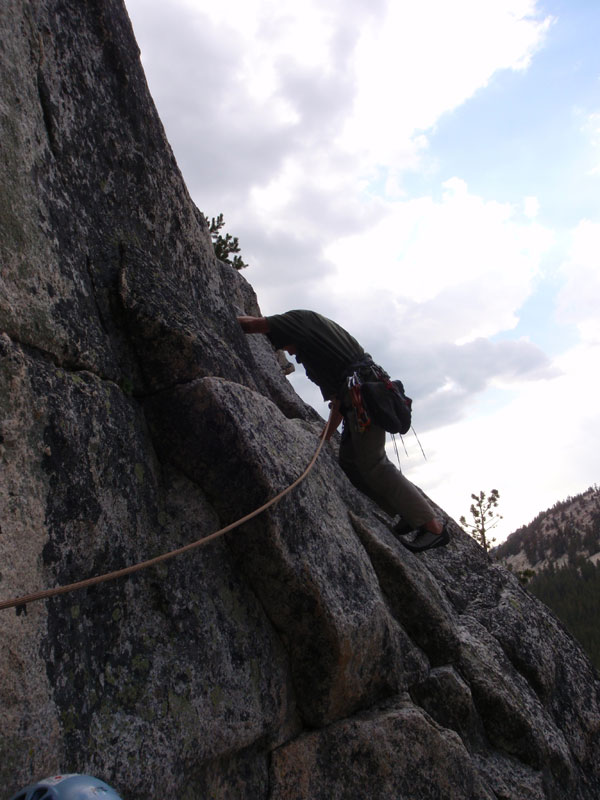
410,334 -> 600,538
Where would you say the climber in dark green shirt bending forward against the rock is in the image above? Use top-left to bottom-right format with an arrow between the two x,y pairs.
238,310 -> 450,552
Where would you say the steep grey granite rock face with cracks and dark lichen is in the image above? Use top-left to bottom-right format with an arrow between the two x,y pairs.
0,0 -> 600,800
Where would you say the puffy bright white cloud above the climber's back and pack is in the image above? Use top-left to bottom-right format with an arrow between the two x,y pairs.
324,178 -> 553,343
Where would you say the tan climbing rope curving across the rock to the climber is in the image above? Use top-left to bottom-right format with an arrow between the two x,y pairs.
0,409 -> 333,611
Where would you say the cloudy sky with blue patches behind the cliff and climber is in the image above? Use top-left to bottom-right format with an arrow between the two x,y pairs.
126,0 -> 600,541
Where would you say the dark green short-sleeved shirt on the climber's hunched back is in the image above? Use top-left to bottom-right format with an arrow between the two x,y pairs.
267,310 -> 367,400
